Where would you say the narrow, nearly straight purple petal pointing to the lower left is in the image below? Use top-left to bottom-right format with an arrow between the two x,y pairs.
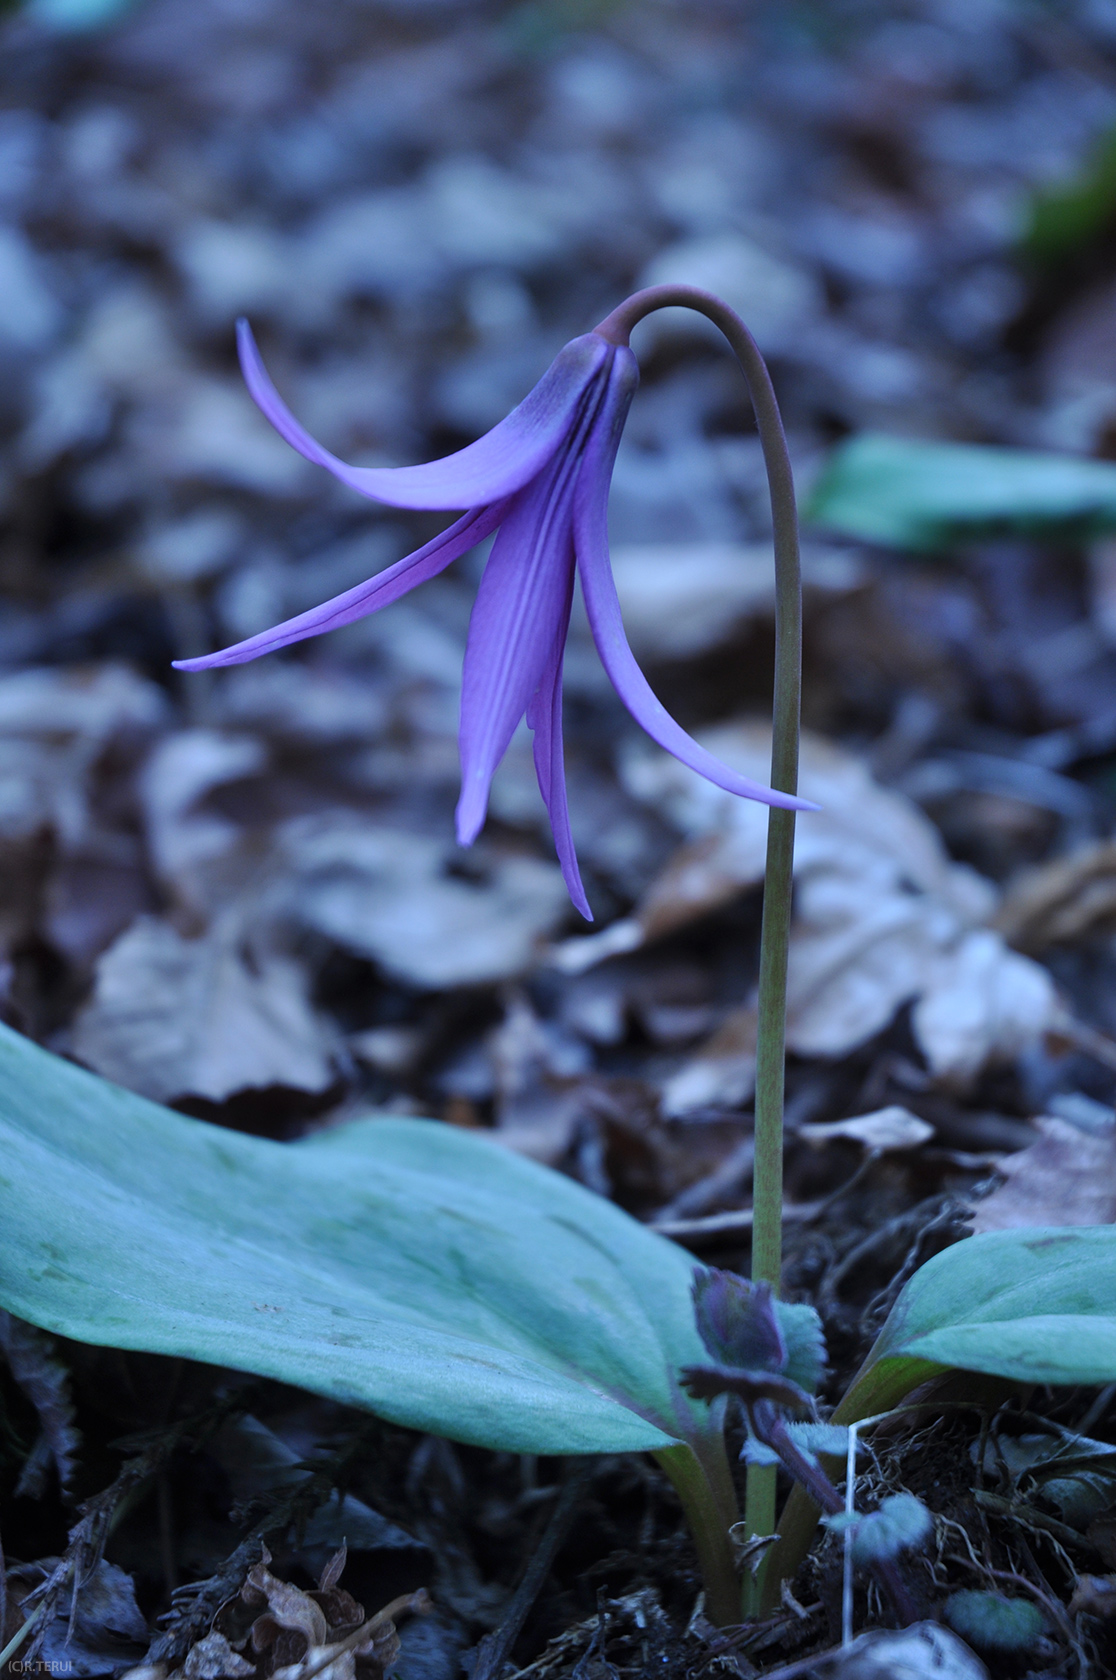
175,502 -> 508,670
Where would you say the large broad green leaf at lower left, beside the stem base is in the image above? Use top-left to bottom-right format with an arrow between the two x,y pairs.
0,1026 -> 713,1455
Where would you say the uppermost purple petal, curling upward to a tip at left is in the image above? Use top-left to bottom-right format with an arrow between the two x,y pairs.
237,321 -> 612,509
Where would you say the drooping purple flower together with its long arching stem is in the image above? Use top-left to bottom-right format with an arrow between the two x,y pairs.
175,286 -> 815,1620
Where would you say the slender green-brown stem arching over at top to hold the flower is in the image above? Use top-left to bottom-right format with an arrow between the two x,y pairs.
597,286 -> 802,1608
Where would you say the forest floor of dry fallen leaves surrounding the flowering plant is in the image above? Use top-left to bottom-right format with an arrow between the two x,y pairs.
0,0 -> 1116,1680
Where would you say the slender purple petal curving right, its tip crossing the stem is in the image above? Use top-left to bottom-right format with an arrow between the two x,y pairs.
573,349 -> 819,811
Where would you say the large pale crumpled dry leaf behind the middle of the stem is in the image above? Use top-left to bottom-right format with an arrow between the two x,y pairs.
611,726 -> 1057,1112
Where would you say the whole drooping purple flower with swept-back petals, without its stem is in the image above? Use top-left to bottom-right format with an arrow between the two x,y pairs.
176,321 -> 813,921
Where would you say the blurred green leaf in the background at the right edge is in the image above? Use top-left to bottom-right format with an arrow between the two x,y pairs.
807,432 -> 1116,551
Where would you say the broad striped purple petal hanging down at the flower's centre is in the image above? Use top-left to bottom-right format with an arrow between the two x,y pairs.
457,454 -> 576,845
